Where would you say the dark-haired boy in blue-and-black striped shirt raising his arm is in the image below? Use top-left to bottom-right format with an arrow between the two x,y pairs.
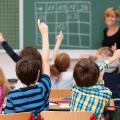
5,20 -> 51,115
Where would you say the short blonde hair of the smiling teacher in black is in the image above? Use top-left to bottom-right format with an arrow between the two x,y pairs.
104,7 -> 120,20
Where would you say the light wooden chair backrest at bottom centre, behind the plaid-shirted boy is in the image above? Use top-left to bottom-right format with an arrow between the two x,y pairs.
41,111 -> 93,120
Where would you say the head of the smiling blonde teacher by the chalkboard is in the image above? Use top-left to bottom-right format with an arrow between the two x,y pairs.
104,7 -> 120,26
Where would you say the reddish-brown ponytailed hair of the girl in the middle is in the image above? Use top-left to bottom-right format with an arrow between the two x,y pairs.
50,53 -> 70,80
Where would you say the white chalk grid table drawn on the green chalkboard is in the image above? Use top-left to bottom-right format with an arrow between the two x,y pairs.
34,1 -> 92,49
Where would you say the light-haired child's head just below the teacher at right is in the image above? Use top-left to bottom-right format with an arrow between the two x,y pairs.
96,47 -> 113,60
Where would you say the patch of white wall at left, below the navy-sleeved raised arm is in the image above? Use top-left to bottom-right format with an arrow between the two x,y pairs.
0,52 -> 16,79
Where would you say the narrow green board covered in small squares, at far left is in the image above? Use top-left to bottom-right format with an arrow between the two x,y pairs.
0,0 -> 19,49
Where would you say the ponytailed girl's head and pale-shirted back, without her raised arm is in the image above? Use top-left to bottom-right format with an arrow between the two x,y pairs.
50,53 -> 74,89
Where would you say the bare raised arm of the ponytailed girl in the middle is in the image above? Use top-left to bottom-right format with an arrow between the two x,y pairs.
53,31 -> 64,60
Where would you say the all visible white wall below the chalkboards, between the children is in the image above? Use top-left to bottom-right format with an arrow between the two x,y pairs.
0,50 -> 96,79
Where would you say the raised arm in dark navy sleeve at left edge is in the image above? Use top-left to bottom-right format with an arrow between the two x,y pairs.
0,33 -> 21,62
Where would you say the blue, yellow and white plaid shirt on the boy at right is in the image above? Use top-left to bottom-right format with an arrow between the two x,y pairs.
71,82 -> 112,120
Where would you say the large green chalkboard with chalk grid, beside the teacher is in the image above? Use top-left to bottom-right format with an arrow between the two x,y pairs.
24,0 -> 120,49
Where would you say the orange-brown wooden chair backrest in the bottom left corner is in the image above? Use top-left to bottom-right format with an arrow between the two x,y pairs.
0,112 -> 32,120
